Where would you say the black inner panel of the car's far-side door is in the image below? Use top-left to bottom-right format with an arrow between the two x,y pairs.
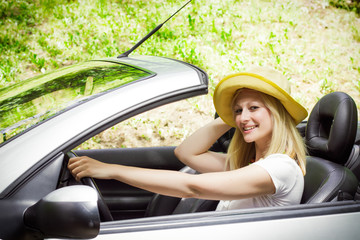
75,147 -> 184,220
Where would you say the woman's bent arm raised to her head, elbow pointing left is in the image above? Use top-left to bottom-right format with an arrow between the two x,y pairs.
175,118 -> 231,173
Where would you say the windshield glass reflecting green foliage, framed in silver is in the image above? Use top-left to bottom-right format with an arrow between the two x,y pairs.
0,61 -> 154,143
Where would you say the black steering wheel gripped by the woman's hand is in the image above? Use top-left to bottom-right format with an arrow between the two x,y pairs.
66,151 -> 114,222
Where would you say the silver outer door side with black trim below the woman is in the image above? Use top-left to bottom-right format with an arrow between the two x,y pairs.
96,201 -> 360,240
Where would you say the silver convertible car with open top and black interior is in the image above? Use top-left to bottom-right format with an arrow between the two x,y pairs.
0,56 -> 360,240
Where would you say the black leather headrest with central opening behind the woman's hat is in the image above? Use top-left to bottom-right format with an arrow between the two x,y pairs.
305,92 -> 357,165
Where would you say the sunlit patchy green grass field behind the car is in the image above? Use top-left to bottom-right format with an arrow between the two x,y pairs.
0,0 -> 360,148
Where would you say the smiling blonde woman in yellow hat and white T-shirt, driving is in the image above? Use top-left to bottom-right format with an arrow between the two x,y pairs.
68,68 -> 307,210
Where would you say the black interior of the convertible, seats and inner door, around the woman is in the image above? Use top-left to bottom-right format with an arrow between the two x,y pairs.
64,92 -> 360,221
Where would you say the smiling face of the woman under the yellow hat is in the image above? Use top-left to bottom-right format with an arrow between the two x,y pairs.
233,89 -> 273,147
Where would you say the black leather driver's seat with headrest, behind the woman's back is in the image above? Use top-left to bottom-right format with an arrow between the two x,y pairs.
301,92 -> 358,203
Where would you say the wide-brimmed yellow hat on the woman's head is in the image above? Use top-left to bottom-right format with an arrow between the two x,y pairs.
213,67 -> 308,127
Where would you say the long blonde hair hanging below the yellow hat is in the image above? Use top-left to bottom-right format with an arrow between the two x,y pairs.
227,89 -> 306,175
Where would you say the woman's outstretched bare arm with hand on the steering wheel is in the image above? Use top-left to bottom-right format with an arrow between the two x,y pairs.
68,157 -> 275,200
